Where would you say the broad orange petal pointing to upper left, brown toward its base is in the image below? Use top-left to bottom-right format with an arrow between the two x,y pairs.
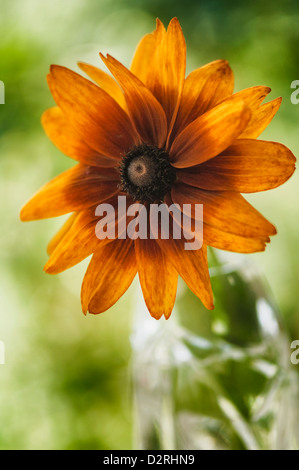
48,65 -> 139,160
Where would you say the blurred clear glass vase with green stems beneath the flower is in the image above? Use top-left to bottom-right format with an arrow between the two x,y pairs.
132,250 -> 299,450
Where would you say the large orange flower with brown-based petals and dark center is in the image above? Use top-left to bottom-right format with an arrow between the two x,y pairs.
21,18 -> 295,319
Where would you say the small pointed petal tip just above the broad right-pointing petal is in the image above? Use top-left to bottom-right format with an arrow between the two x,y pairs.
239,98 -> 281,139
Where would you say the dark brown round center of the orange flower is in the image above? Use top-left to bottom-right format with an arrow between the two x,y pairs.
120,144 -> 176,203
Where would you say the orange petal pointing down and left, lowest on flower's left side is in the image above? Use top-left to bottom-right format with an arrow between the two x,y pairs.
81,239 -> 137,314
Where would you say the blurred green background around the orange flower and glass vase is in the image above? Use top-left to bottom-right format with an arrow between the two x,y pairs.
0,0 -> 299,449
